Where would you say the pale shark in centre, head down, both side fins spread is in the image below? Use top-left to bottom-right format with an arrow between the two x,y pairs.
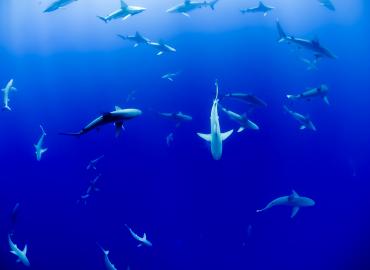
197,81 -> 234,160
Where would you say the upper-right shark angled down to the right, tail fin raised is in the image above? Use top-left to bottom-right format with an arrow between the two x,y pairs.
276,20 -> 337,59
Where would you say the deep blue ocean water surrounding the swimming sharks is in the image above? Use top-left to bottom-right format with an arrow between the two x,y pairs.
0,0 -> 370,270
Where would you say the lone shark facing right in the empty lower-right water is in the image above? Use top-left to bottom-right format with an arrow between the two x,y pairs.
257,190 -> 315,218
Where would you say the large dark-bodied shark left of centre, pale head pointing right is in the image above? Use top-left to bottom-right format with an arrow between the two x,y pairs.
59,106 -> 142,137
